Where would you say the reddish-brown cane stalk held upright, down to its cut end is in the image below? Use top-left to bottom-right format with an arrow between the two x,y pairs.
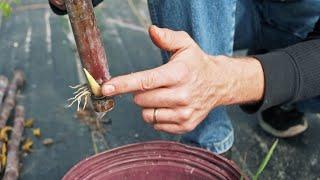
65,0 -> 114,112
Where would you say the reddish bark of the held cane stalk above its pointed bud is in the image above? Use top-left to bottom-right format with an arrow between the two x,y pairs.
65,0 -> 111,84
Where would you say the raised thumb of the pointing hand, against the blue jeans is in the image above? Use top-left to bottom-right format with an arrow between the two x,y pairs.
149,25 -> 194,52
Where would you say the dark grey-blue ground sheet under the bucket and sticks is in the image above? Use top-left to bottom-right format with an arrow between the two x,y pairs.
0,0 -> 320,180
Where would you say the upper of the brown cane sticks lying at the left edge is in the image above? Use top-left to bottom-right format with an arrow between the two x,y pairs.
0,70 -> 24,170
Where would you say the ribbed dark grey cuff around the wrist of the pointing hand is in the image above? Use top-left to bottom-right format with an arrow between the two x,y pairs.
241,51 -> 296,113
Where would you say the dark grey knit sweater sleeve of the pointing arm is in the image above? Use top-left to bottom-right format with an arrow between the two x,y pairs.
241,19 -> 320,113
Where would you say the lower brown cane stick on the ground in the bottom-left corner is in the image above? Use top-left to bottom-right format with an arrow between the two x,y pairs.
3,105 -> 24,180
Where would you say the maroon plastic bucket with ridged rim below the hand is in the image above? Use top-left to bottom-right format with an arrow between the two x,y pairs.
63,141 -> 247,180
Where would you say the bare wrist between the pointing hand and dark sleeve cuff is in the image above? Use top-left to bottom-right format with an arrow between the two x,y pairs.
215,56 -> 264,105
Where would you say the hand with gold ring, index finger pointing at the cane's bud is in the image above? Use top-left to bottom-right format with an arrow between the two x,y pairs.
102,26 -> 264,134
